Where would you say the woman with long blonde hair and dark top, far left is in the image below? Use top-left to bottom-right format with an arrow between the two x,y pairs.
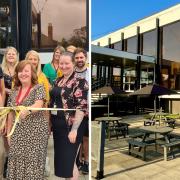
1,46 -> 19,97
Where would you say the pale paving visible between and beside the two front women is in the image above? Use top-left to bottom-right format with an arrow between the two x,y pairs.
47,136 -> 89,180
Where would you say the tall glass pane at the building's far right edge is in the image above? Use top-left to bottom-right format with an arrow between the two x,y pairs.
161,22 -> 180,90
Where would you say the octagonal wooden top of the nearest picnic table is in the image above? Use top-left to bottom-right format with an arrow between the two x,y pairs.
140,126 -> 173,134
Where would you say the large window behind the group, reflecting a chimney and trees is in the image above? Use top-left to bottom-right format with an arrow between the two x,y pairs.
32,0 -> 87,49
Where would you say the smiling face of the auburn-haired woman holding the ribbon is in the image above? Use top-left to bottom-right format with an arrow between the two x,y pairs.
18,64 -> 32,84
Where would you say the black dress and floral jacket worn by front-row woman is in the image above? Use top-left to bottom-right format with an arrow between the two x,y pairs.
50,73 -> 88,178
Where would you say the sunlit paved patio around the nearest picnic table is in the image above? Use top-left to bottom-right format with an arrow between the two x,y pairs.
92,116 -> 180,180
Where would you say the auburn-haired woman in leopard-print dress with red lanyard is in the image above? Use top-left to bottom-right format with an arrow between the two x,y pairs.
7,60 -> 48,180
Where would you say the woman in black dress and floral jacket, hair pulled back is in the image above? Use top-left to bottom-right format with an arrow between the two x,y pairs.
50,52 -> 88,180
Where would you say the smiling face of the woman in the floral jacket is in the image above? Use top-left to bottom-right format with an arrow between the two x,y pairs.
59,55 -> 74,76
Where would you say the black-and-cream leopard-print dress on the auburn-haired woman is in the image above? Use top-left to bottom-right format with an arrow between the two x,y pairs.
7,85 -> 48,180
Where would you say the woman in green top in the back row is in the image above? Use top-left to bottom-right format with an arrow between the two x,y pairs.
43,46 -> 65,85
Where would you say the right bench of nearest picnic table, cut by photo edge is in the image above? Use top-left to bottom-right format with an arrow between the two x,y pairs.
161,139 -> 180,161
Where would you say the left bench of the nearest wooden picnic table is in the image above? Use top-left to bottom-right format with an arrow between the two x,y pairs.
128,139 -> 153,161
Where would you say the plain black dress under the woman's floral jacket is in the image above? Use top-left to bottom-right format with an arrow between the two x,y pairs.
50,86 -> 85,178
